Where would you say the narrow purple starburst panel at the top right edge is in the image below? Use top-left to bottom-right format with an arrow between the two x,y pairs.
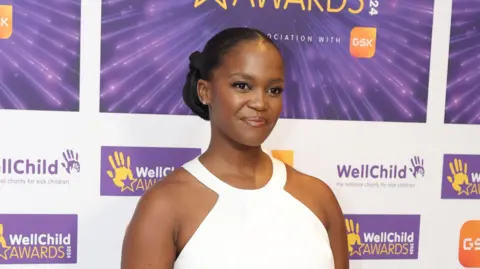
445,0 -> 480,124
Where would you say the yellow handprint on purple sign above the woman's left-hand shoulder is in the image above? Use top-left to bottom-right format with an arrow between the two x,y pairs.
107,151 -> 137,192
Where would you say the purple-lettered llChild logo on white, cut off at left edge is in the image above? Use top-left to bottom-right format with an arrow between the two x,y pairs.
0,149 -> 80,185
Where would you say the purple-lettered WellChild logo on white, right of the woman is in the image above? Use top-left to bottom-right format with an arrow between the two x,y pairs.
337,156 -> 425,188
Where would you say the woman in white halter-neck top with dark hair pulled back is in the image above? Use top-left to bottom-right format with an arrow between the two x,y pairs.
122,28 -> 349,269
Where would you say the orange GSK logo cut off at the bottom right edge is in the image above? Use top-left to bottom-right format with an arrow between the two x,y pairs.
458,220 -> 480,268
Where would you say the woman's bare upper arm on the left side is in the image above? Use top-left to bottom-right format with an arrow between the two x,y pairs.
121,186 -> 176,269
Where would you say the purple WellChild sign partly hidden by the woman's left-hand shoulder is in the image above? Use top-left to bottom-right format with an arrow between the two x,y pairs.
100,146 -> 201,196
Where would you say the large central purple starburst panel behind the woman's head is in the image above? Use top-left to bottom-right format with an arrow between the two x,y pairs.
100,0 -> 433,122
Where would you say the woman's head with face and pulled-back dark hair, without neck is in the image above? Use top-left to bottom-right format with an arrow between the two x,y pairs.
184,29 -> 284,146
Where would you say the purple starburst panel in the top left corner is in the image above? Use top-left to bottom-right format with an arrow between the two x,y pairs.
0,0 -> 80,111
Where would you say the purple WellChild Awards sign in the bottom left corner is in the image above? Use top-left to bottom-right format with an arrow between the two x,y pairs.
0,215 -> 78,265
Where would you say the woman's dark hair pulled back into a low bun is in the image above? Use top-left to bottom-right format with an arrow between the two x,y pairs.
183,27 -> 278,120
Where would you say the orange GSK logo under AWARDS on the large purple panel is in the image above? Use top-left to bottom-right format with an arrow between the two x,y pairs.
350,27 -> 377,58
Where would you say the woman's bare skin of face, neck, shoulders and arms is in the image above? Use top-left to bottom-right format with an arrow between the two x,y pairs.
121,40 -> 349,269
